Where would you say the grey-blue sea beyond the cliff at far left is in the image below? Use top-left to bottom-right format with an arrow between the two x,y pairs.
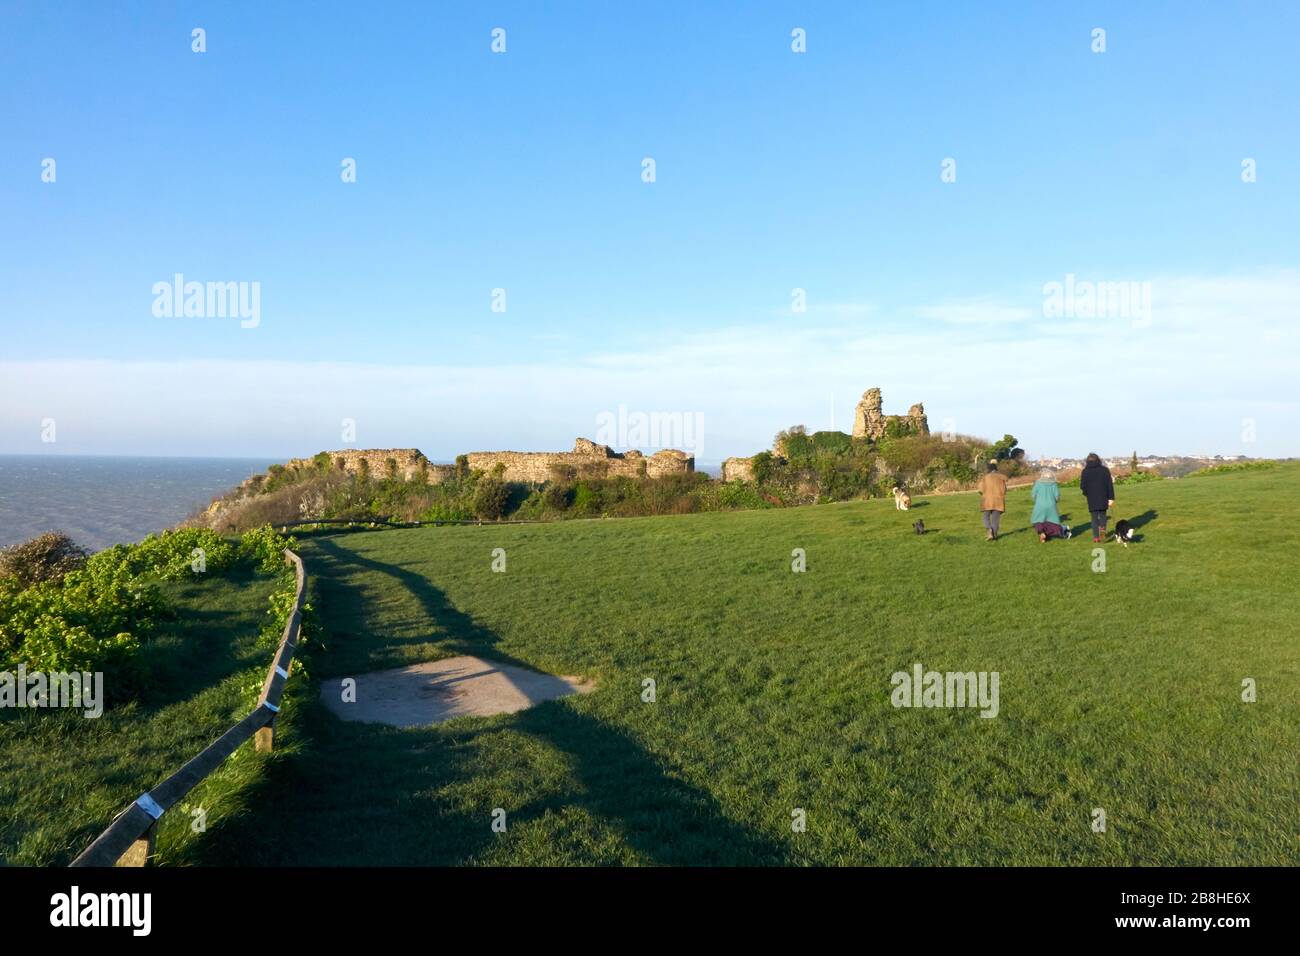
0,454 -> 273,551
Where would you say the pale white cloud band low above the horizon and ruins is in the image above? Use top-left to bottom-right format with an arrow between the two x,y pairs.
0,272 -> 1300,460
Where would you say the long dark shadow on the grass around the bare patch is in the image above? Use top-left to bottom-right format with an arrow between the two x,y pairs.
178,538 -> 787,866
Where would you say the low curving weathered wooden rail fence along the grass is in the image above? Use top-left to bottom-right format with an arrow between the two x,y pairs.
72,550 -> 307,866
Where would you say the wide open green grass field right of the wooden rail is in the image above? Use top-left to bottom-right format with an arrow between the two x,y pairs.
170,464 -> 1300,865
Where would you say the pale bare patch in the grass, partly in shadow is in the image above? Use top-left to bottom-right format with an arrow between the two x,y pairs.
321,657 -> 595,727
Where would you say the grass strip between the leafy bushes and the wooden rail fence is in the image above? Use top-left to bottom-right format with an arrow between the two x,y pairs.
0,568 -> 287,866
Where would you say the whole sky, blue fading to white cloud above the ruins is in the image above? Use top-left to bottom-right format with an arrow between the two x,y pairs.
0,3 -> 1300,462
